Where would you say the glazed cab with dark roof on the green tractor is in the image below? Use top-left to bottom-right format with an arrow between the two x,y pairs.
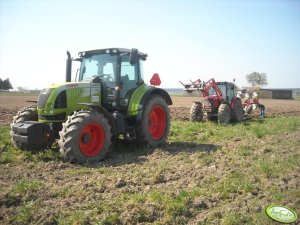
77,48 -> 147,109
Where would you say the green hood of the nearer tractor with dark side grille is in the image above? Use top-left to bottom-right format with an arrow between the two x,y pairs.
38,82 -> 101,122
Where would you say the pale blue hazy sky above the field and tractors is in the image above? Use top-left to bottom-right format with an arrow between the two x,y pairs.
0,0 -> 300,89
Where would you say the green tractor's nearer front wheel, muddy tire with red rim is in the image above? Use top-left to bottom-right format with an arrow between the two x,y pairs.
58,110 -> 111,163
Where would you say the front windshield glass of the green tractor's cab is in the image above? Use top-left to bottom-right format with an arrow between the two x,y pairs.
79,54 -> 117,85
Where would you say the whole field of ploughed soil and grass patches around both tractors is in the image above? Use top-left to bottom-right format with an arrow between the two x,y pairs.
0,92 -> 300,225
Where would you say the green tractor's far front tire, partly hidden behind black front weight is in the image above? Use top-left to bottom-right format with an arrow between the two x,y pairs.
10,105 -> 53,151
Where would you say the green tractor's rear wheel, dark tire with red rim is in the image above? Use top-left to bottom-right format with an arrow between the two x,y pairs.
136,96 -> 170,147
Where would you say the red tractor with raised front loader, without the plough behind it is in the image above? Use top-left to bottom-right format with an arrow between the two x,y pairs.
180,78 -> 244,124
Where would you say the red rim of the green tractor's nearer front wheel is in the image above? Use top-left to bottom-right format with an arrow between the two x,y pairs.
79,123 -> 105,156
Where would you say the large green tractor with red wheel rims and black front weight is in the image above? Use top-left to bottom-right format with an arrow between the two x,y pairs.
10,48 -> 172,163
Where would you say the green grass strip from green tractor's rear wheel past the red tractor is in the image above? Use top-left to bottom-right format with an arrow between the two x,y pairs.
169,117 -> 300,143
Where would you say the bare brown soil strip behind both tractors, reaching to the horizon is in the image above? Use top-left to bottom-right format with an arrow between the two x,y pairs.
0,95 -> 300,125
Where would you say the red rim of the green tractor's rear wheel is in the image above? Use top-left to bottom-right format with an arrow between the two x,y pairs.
148,106 -> 167,140
